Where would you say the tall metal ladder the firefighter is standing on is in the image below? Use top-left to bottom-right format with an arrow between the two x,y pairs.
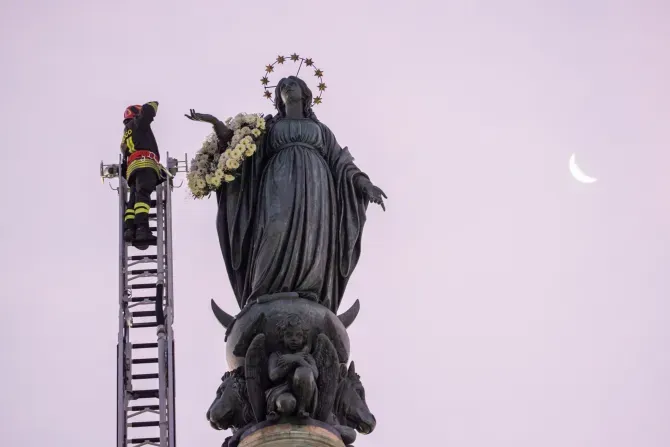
100,154 -> 188,447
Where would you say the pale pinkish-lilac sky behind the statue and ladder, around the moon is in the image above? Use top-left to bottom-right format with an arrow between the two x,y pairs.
0,0 -> 670,447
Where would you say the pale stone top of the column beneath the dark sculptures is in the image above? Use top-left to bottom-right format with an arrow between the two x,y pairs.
238,424 -> 344,447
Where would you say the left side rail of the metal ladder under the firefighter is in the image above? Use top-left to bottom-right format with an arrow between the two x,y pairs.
116,156 -> 128,447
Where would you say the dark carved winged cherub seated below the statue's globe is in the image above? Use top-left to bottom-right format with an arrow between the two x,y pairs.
245,314 -> 339,422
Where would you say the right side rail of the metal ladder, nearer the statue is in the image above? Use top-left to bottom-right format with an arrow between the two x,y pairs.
165,158 -> 177,447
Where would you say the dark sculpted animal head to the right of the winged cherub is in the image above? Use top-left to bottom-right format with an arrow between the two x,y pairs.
333,362 -> 377,435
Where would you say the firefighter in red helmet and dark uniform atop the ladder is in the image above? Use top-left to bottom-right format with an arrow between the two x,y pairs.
121,101 -> 162,250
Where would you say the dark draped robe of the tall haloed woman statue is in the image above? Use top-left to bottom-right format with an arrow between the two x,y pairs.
217,118 -> 368,312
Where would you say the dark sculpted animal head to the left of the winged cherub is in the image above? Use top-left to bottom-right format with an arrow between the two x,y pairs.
207,367 -> 253,430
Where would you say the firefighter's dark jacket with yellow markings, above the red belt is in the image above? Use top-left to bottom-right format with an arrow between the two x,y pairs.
121,103 -> 160,179
